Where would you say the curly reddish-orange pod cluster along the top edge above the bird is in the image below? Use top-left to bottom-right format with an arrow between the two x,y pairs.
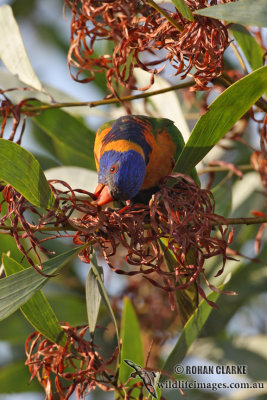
65,0 -> 229,94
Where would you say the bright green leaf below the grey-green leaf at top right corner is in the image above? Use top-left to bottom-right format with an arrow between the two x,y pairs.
230,24 -> 264,71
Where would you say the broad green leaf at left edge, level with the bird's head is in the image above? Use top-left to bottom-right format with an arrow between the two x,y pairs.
0,139 -> 55,209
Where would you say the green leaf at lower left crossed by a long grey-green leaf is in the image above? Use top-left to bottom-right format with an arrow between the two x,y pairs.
3,254 -> 66,346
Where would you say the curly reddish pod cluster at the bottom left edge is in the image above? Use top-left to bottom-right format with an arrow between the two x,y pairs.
25,324 -> 118,400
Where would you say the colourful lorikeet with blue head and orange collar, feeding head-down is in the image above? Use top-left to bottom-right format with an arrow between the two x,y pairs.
94,115 -> 184,205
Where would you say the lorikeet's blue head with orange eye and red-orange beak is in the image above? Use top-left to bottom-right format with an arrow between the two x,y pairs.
95,150 -> 146,205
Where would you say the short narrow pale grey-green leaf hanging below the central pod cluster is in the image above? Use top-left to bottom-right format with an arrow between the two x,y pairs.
85,254 -> 104,334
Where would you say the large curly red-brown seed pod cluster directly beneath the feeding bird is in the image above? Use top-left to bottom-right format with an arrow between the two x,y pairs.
0,174 -> 232,304
